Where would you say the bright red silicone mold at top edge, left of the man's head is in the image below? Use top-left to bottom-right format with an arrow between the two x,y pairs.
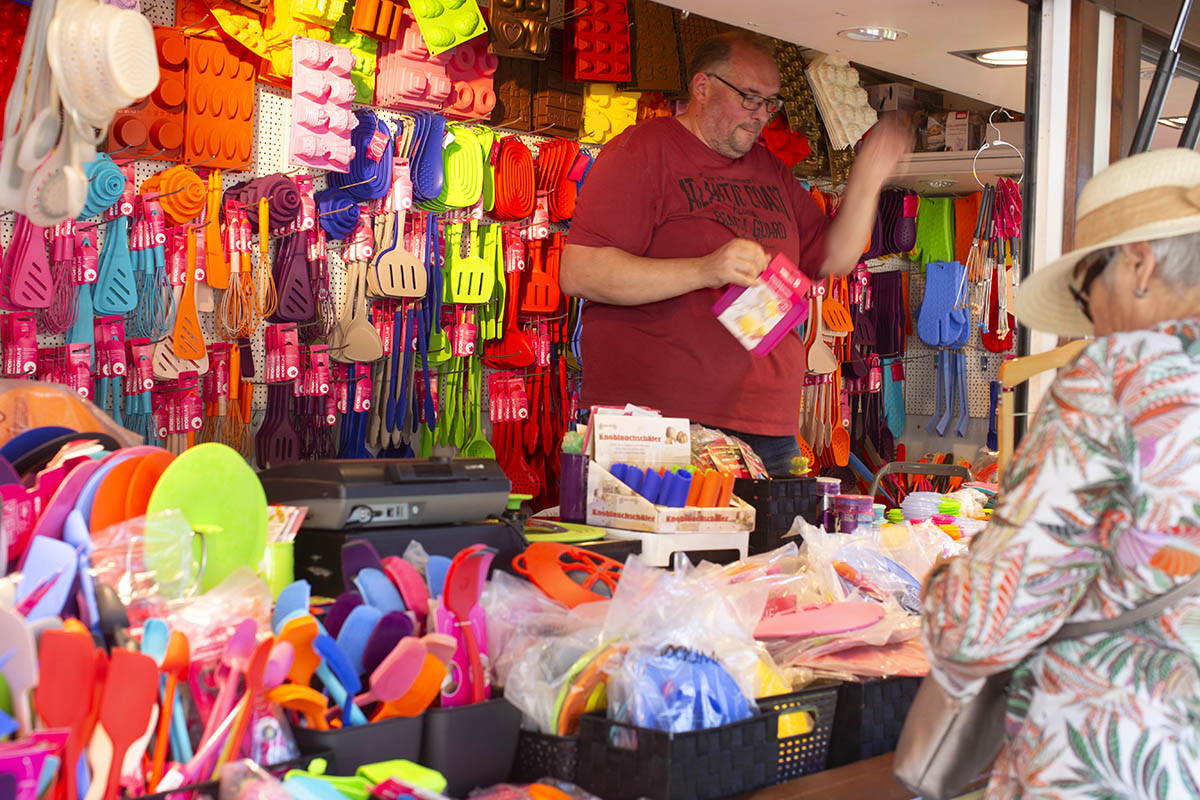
563,0 -> 632,83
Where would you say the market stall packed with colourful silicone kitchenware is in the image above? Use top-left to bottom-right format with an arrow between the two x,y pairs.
0,0 -> 1025,800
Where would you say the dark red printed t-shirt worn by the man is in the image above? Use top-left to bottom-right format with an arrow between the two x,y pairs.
566,118 -> 828,435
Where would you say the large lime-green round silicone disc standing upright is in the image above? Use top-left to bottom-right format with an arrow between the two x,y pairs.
145,443 -> 266,591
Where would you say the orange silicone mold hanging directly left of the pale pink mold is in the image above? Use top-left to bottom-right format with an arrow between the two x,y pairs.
182,37 -> 254,169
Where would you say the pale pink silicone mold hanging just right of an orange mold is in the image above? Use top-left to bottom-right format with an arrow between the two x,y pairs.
290,36 -> 358,173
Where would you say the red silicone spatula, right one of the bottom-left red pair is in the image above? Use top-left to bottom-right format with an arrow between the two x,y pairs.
92,650 -> 158,800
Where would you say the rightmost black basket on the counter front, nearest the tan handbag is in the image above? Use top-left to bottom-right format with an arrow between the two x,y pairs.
829,678 -> 920,769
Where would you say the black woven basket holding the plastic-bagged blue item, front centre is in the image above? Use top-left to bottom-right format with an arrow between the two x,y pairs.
576,711 -> 779,800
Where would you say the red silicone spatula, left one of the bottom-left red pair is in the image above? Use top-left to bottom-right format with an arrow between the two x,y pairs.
34,631 -> 96,800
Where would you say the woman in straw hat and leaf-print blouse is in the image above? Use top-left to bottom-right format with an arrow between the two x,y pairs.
924,150 -> 1200,798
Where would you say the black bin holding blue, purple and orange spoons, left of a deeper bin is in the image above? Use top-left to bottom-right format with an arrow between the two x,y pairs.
292,715 -> 425,775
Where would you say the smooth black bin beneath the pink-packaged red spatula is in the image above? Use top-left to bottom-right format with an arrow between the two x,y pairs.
420,699 -> 521,798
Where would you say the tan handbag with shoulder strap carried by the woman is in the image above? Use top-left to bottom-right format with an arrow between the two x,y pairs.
892,576 -> 1200,800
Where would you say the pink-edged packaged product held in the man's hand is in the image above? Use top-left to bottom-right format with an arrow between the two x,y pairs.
713,253 -> 812,359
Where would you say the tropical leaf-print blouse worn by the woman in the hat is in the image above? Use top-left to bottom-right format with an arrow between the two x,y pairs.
923,319 -> 1200,799
